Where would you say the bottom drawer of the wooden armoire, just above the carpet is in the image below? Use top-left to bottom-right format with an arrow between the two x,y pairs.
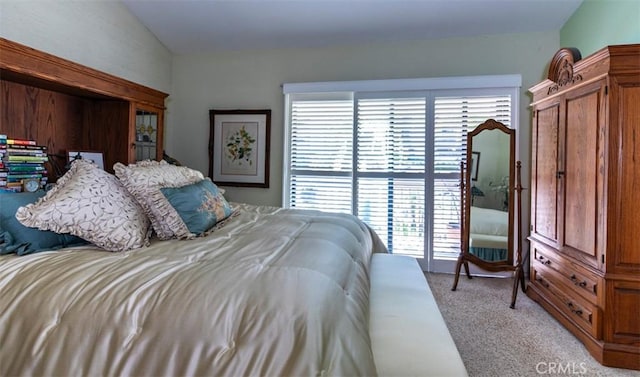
531,268 -> 602,339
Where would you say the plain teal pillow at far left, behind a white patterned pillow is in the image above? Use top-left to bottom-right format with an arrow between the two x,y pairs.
0,190 -> 88,255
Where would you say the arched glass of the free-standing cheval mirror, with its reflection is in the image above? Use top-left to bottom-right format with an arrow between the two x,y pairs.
467,129 -> 511,262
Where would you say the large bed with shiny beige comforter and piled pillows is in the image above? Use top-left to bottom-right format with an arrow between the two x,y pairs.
0,159 -> 466,376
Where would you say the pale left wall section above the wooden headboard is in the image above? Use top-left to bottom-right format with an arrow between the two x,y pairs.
0,0 -> 172,93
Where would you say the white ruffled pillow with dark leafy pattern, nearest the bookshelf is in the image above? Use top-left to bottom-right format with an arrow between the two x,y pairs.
16,160 -> 150,251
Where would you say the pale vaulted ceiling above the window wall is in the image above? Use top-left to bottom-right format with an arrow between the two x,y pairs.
122,0 -> 582,54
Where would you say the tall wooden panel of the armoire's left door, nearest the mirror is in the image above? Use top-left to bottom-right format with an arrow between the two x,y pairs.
532,103 -> 560,243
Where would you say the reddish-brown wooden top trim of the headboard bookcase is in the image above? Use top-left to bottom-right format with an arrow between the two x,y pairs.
0,38 -> 168,109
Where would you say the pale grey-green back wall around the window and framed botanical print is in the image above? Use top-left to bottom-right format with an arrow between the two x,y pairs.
165,32 -> 559,205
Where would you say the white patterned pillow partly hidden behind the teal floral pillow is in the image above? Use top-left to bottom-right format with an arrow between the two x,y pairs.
113,161 -> 204,240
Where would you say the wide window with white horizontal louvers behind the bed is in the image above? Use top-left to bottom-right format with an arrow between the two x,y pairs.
283,75 -> 520,258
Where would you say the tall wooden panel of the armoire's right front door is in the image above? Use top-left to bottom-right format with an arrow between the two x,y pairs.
562,85 -> 603,266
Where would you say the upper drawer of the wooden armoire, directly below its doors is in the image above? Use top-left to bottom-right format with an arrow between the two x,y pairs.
532,243 -> 601,304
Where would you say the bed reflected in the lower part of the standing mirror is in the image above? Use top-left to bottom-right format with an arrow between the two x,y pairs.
469,206 -> 509,261
